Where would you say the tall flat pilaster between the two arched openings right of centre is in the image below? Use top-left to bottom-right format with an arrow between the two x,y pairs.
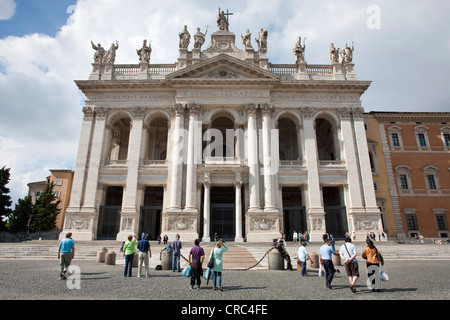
301,107 -> 326,241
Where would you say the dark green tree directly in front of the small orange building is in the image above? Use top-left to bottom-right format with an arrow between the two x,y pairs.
30,182 -> 61,232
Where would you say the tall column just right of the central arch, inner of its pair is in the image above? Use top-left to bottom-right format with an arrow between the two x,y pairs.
245,104 -> 261,211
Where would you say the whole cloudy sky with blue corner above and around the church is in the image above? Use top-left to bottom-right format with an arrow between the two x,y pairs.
0,0 -> 450,208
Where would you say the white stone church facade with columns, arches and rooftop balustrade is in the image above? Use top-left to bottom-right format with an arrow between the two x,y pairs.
61,13 -> 381,242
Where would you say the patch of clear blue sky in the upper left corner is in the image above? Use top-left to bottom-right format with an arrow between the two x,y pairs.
0,0 -> 77,38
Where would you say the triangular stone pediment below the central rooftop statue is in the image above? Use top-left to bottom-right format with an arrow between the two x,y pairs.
167,54 -> 280,81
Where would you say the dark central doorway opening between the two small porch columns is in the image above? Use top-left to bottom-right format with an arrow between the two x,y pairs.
210,186 -> 236,241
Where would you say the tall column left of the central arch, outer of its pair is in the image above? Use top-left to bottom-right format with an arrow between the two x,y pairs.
169,104 -> 184,211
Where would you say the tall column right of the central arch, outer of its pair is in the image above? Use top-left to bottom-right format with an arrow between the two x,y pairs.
261,104 -> 277,211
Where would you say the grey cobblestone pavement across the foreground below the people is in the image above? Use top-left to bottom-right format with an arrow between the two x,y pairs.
0,259 -> 450,301
